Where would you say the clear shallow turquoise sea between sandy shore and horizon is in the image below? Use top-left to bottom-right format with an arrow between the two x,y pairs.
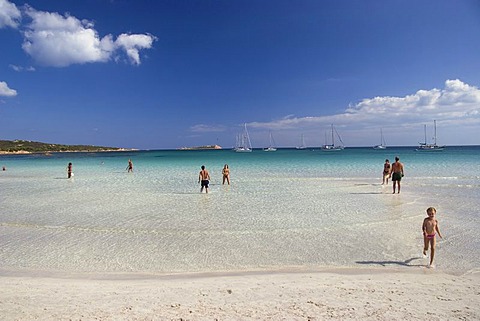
0,146 -> 480,273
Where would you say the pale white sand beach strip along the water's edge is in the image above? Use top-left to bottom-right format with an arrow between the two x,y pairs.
0,268 -> 480,320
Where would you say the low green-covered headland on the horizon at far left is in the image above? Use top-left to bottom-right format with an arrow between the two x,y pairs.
0,140 -> 122,153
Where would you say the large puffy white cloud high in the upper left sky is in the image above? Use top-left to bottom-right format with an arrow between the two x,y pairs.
19,5 -> 156,67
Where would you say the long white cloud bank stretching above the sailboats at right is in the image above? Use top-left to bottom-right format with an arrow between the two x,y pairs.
249,79 -> 480,129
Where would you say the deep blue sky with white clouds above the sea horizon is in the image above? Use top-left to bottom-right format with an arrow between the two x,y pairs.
0,0 -> 480,149
